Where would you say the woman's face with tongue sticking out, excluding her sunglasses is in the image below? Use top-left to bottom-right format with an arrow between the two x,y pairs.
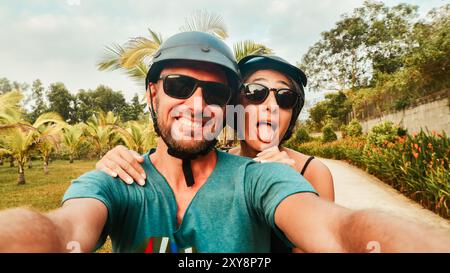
240,70 -> 292,151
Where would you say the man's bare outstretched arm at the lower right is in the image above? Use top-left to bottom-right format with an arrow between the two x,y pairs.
275,193 -> 450,252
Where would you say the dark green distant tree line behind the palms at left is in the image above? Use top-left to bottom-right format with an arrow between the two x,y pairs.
0,77 -> 146,124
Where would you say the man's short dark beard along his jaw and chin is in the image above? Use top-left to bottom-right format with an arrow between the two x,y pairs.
155,101 -> 218,156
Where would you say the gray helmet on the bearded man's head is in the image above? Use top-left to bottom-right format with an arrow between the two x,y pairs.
145,31 -> 240,90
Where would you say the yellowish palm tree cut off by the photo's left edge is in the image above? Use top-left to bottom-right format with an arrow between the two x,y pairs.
0,113 -> 64,185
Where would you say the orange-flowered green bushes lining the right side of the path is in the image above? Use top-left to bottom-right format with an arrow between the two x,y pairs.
291,126 -> 450,219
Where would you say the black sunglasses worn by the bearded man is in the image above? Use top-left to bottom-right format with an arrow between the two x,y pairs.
159,74 -> 232,106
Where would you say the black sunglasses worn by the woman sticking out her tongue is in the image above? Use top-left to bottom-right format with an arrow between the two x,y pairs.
242,83 -> 299,109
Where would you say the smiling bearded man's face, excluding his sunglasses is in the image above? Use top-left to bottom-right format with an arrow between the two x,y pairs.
147,62 -> 227,154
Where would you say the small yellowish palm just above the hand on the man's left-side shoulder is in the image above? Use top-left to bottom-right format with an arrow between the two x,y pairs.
84,112 -> 120,158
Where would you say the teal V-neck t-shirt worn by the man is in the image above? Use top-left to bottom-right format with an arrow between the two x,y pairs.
63,150 -> 316,252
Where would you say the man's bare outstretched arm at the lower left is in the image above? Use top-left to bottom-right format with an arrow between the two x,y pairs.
0,198 -> 108,252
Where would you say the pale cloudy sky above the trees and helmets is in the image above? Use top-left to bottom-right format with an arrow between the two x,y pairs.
0,0 -> 449,110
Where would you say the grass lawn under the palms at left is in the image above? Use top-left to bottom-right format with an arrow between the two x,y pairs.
0,160 -> 111,252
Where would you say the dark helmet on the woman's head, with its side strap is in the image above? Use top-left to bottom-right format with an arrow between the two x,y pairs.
238,55 -> 307,141
